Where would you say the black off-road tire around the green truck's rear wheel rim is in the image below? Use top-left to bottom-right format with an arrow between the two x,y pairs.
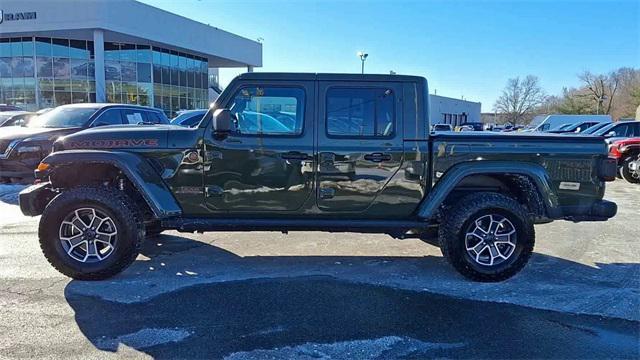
438,192 -> 535,282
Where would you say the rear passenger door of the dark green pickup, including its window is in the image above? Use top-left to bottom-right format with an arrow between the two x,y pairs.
316,81 -> 403,213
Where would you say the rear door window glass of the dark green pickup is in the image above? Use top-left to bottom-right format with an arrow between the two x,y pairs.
326,88 -> 395,137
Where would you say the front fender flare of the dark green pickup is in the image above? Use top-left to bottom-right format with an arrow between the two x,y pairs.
42,150 -> 182,219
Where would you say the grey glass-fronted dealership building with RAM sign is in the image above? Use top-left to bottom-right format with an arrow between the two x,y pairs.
0,0 -> 262,115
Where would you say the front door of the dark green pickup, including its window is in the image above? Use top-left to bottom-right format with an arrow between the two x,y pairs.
204,81 -> 315,213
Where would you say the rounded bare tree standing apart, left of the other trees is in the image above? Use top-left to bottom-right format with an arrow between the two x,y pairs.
493,75 -> 546,125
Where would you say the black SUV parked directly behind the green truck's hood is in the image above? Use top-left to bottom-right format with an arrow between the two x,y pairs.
0,104 -> 169,182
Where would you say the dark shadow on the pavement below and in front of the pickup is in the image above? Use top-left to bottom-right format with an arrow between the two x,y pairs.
65,235 -> 640,359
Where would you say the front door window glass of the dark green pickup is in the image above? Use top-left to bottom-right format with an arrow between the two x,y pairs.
228,87 -> 305,135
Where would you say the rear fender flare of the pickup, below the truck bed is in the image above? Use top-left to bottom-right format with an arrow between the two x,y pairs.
418,161 -> 558,220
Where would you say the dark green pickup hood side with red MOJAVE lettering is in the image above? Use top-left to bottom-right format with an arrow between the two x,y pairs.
55,125 -> 192,150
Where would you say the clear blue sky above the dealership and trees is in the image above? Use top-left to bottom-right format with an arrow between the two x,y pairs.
143,0 -> 640,111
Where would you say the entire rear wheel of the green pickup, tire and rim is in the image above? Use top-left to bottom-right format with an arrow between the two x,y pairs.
438,192 -> 535,282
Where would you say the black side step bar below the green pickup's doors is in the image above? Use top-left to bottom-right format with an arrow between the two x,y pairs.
162,218 -> 433,234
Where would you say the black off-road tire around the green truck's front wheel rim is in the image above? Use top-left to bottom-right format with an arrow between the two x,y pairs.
38,186 -> 144,280
